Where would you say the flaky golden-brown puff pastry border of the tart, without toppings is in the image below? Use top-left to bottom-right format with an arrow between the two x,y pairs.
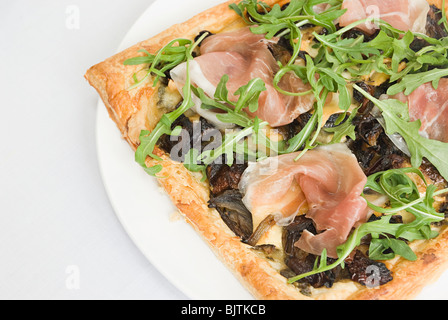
85,0 -> 448,300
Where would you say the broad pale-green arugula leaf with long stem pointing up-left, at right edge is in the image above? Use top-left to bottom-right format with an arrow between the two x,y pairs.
353,84 -> 448,180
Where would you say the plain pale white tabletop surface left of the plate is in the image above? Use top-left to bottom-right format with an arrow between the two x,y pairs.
0,0 -> 187,299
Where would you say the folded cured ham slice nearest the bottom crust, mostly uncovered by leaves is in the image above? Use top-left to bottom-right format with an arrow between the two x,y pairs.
239,144 -> 368,258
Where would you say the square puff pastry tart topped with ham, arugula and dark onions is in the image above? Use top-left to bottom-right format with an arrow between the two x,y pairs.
85,0 -> 448,300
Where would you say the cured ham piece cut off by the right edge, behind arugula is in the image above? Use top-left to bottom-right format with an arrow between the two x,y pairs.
392,78 -> 448,143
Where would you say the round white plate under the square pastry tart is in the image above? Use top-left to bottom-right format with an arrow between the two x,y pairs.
97,0 -> 448,300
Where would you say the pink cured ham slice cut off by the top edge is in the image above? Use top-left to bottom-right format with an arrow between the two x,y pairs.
339,0 -> 430,34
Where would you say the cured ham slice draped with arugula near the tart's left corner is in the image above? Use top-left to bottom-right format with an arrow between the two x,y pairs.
171,28 -> 315,127
